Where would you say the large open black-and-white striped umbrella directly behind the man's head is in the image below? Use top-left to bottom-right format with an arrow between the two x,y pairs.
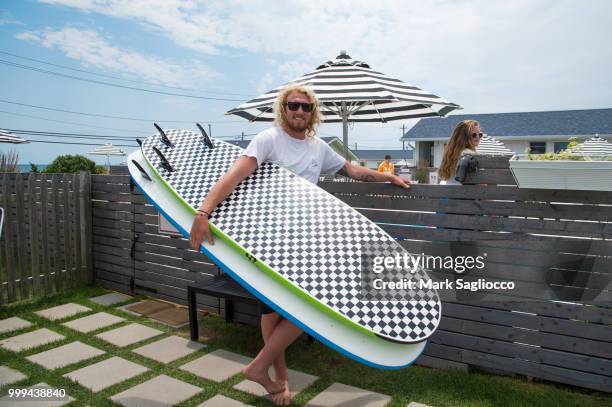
227,51 -> 461,158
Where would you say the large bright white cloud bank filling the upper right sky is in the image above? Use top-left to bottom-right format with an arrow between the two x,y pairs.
41,0 -> 612,112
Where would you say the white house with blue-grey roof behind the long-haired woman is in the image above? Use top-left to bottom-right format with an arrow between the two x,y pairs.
401,109 -> 612,167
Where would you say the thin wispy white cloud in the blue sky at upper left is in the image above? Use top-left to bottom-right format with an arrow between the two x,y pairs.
15,27 -> 220,86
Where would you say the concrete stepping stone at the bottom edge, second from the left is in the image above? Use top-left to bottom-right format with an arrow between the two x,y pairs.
110,375 -> 202,407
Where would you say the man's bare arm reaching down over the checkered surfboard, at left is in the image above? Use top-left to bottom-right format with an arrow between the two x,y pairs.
189,155 -> 257,250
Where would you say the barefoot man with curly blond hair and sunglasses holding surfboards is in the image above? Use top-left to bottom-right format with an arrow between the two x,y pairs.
190,86 -> 409,405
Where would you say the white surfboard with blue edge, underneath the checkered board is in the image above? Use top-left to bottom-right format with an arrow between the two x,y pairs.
128,151 -> 426,369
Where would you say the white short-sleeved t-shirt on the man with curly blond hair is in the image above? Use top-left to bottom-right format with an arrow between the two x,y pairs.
242,127 -> 345,184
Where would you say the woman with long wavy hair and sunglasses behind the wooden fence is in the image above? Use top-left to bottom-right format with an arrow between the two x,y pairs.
438,120 -> 482,185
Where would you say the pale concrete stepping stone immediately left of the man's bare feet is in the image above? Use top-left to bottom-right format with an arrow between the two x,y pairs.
181,349 -> 251,382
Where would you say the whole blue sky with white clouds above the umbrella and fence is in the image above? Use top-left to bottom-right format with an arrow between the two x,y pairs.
0,0 -> 612,164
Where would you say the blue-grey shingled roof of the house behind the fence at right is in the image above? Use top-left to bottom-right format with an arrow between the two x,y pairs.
402,109 -> 612,140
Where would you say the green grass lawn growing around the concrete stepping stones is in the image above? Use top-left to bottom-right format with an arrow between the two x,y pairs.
0,287 -> 612,407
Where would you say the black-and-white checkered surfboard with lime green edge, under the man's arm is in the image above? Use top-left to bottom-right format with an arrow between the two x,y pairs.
142,130 -> 441,343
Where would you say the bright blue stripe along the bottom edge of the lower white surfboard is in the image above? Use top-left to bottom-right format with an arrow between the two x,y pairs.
132,177 -> 425,370
